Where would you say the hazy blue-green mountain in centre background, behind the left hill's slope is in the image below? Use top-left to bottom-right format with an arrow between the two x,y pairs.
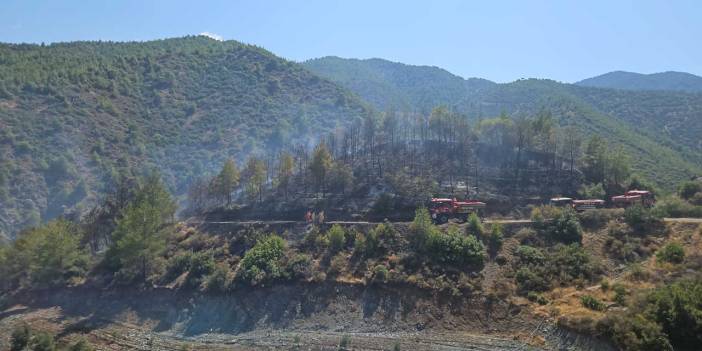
303,56 -> 495,114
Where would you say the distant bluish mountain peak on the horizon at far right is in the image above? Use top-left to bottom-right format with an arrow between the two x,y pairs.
575,71 -> 702,92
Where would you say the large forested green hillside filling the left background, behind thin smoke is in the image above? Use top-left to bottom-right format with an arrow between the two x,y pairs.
0,36 -> 368,238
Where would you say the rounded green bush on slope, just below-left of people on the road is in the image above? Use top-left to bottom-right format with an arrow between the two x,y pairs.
240,235 -> 286,285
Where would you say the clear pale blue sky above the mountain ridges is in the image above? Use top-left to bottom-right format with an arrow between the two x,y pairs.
0,0 -> 702,82
